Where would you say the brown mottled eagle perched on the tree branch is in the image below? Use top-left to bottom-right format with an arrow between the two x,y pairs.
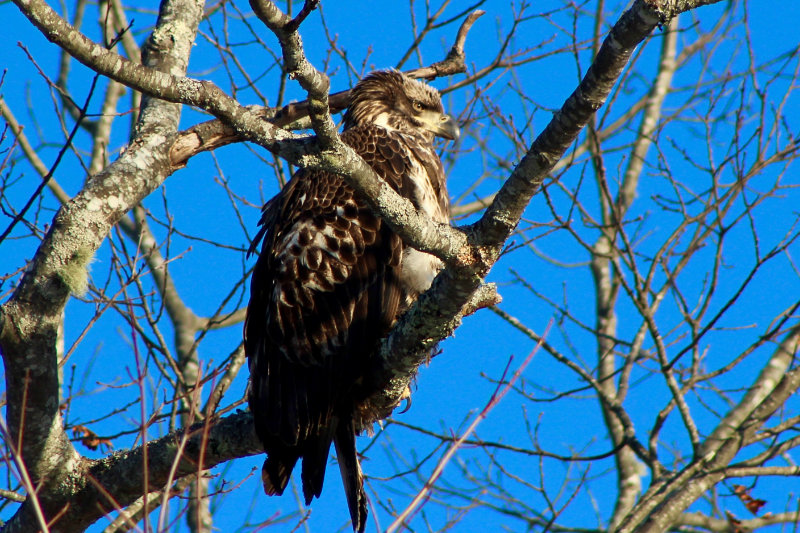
244,70 -> 459,533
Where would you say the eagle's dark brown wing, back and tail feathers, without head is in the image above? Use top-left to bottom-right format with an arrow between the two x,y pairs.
245,126 -> 412,529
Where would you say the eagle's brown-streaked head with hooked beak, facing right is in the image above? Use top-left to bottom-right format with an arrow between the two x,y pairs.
344,70 -> 461,141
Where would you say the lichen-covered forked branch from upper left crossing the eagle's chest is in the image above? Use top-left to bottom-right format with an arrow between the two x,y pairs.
15,0 -> 482,270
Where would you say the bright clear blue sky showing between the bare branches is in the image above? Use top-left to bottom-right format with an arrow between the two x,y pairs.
0,0 -> 800,531
